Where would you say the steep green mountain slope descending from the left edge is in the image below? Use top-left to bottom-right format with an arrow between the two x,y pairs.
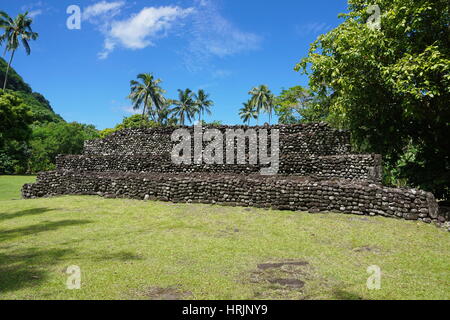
0,58 -> 64,124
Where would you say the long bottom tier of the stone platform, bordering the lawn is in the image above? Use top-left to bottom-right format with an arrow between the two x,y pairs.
22,171 -> 445,223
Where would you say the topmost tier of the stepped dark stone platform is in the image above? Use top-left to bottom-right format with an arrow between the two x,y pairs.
84,123 -> 351,157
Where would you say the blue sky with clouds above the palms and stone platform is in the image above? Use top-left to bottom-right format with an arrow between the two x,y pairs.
0,0 -> 347,129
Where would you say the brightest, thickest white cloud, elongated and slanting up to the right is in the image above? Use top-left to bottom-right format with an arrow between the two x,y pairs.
99,6 -> 194,59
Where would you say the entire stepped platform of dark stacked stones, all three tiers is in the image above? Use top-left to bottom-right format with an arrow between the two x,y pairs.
22,124 -> 445,223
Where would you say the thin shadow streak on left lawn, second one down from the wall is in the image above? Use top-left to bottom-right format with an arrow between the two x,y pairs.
0,220 -> 92,241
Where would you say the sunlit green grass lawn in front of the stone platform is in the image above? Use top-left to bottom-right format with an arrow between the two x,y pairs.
0,177 -> 450,299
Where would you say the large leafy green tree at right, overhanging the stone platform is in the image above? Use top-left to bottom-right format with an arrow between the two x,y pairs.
296,0 -> 450,199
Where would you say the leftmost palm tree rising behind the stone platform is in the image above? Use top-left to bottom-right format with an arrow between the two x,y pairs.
128,73 -> 166,121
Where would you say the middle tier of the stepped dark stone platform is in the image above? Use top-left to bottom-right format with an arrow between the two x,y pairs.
56,153 -> 382,183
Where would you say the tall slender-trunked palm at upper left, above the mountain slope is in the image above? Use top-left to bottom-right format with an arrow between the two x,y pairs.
0,11 -> 39,90
